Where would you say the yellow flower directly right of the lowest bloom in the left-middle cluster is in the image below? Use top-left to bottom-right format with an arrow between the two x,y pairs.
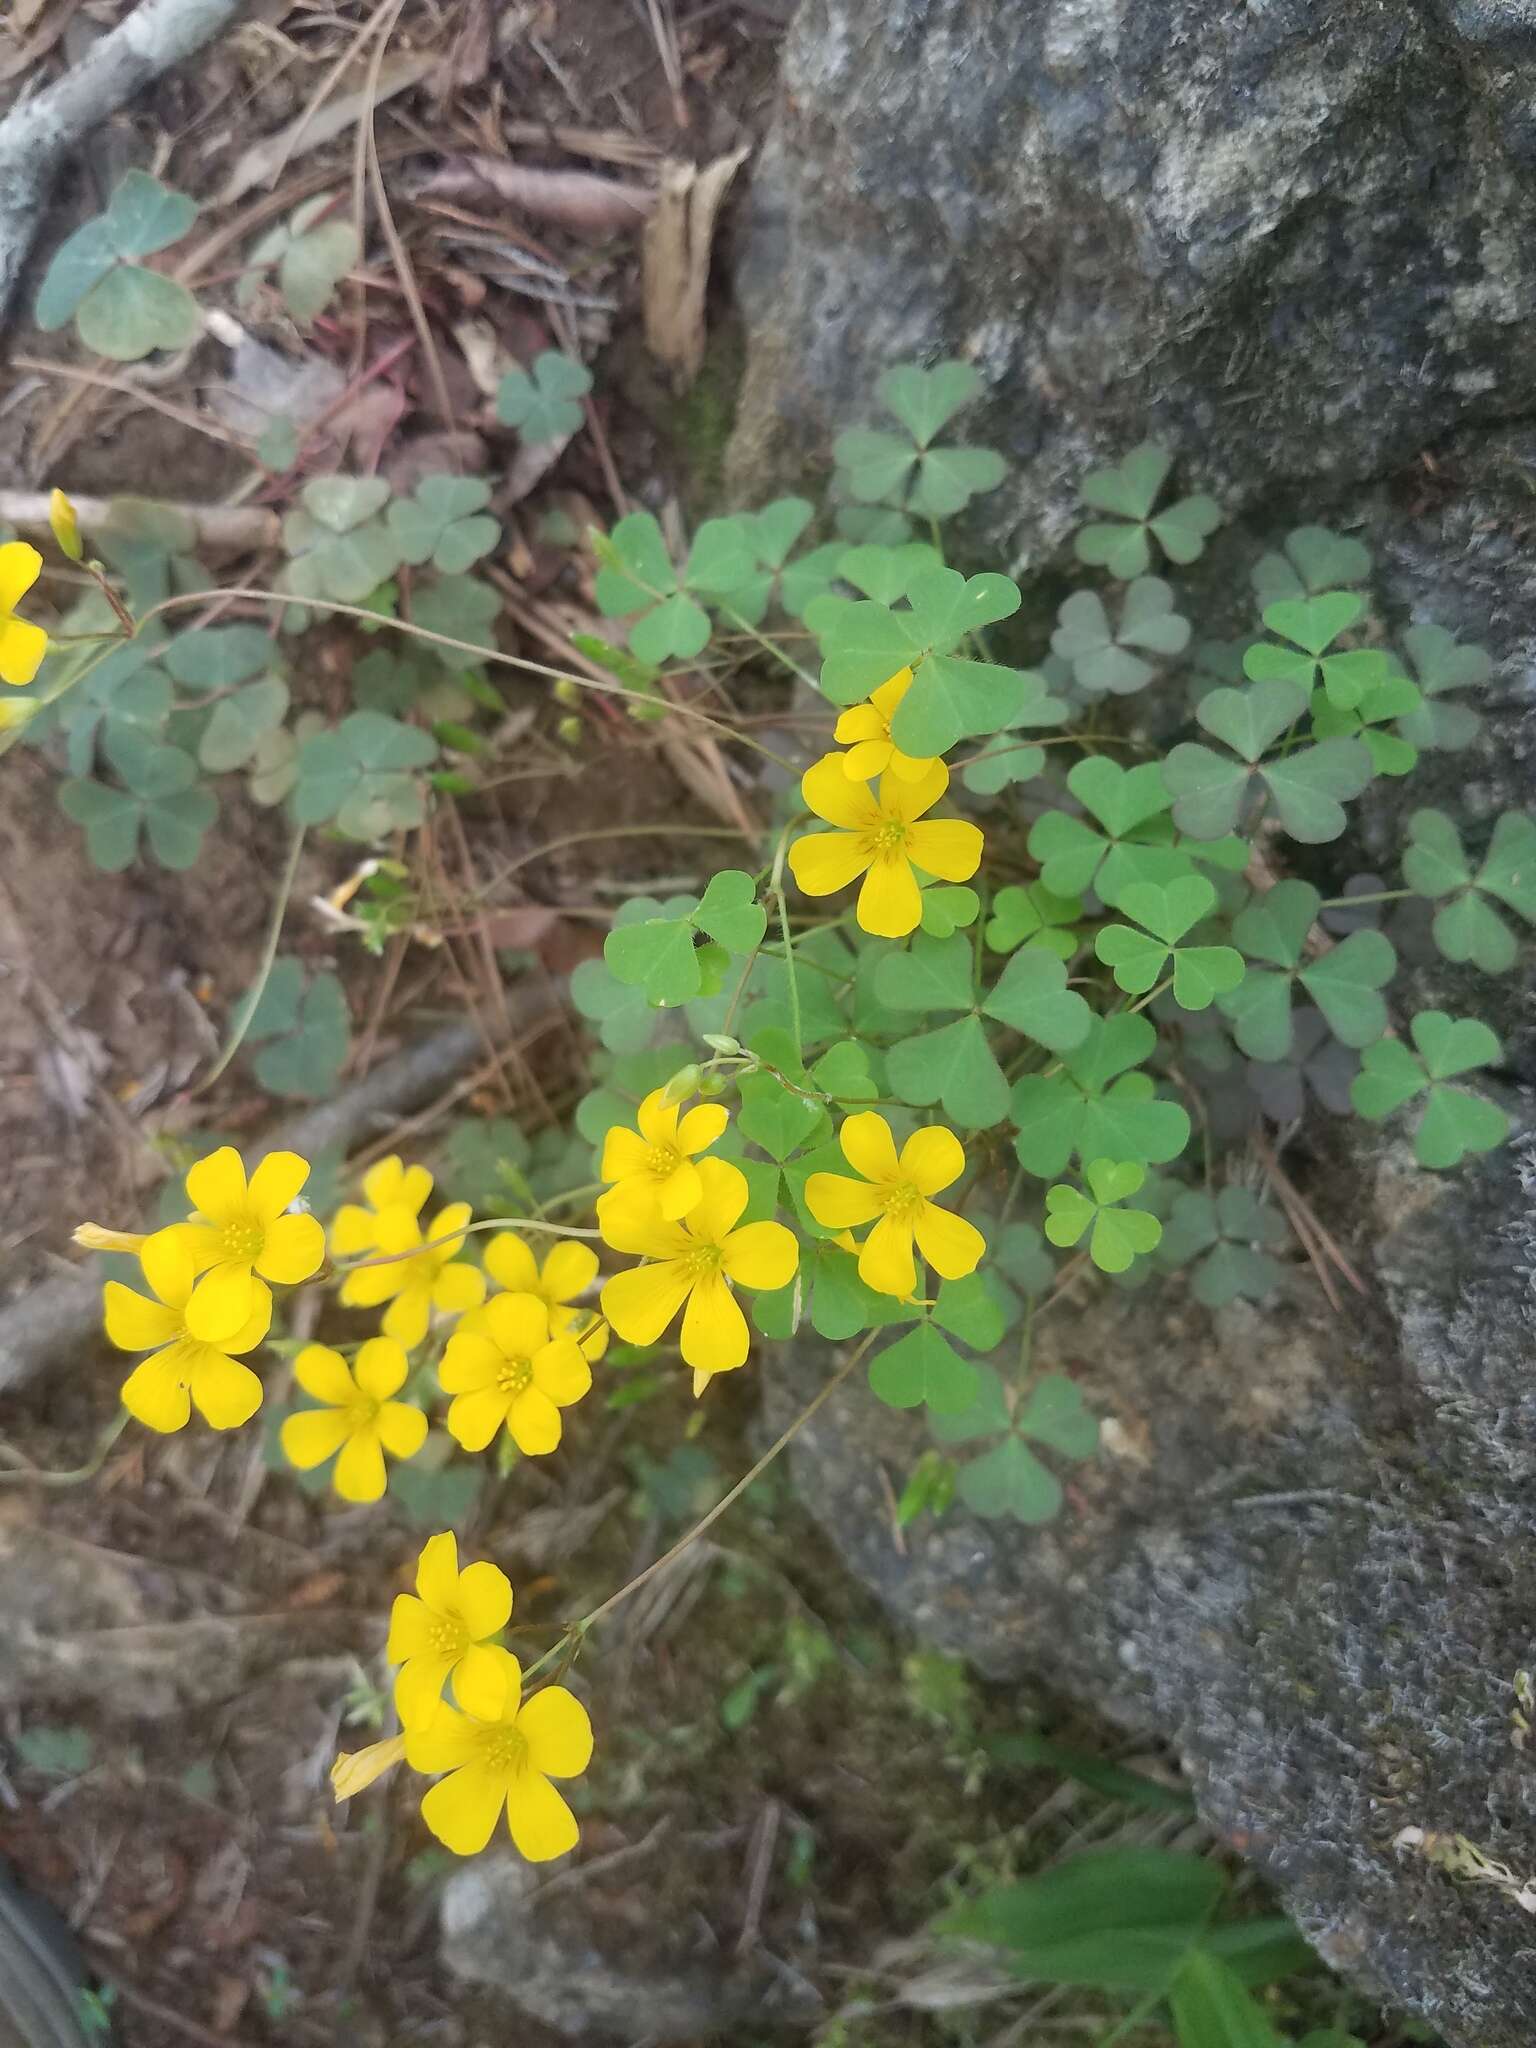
438,1294 -> 592,1458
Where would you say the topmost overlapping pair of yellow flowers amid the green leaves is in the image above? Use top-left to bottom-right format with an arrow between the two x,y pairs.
788,668 -> 981,938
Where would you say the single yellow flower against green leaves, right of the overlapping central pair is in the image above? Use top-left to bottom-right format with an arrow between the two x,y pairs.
806,1110 -> 987,1294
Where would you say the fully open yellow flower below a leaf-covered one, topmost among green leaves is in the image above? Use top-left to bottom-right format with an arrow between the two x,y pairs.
788,754 -> 981,938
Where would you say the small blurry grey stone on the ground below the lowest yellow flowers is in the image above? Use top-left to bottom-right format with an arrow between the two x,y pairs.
442,1843 -> 821,2048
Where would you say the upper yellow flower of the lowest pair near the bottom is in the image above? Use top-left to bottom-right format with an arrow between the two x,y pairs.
385,1530 -> 512,1729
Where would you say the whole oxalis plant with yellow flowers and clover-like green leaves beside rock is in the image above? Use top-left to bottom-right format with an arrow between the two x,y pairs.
0,344 -> 1536,1925
